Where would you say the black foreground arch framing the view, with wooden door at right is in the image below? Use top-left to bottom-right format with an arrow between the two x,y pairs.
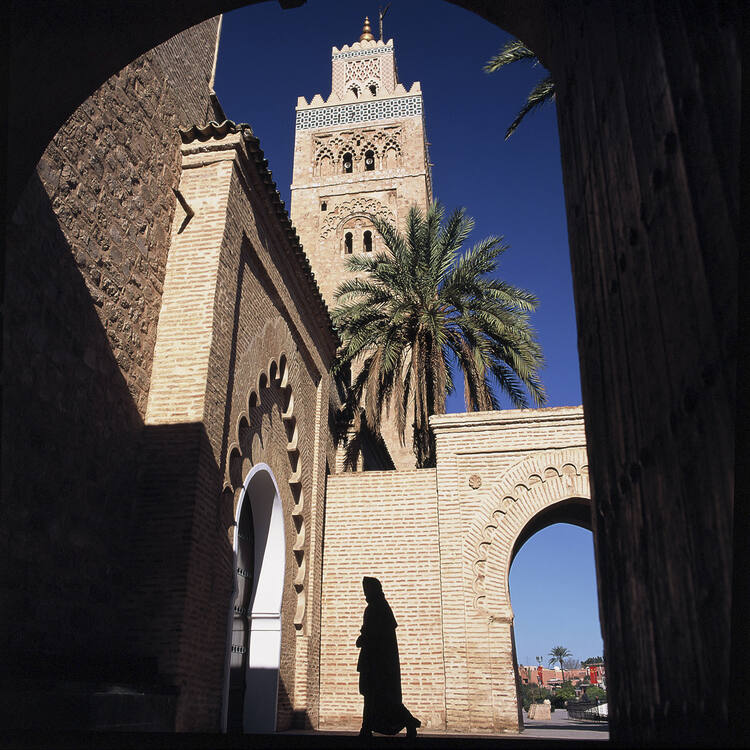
8,0 -> 747,743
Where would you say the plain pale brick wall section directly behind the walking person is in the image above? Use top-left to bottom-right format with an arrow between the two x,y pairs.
320,469 -> 445,729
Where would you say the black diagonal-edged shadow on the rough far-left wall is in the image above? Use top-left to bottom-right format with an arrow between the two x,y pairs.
0,175 -> 142,679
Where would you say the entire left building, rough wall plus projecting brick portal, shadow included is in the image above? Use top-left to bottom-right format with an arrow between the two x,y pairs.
2,19 -> 335,731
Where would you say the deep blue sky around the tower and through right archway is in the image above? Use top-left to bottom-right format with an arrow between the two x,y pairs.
215,0 -> 602,663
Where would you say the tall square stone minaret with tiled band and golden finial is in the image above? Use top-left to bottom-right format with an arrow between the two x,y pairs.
291,19 -> 432,469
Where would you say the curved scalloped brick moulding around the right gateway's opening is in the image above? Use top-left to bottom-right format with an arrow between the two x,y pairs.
465,447 -> 591,622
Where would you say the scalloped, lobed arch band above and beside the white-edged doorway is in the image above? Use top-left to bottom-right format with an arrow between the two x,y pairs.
223,351 -> 307,634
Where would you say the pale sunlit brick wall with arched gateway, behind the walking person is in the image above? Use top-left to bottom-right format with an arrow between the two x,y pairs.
321,407 -> 591,733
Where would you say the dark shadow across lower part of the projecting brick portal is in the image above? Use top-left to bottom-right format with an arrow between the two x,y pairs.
125,423 -> 234,704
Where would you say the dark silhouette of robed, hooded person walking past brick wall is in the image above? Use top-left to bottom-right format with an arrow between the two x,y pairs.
357,576 -> 422,737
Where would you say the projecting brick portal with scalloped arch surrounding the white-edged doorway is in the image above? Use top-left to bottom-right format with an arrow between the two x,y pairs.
134,129 -> 335,730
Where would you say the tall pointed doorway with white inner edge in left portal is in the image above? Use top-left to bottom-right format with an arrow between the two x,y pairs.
224,464 -> 286,732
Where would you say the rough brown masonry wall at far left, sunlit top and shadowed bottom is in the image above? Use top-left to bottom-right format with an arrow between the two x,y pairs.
0,19 -> 218,677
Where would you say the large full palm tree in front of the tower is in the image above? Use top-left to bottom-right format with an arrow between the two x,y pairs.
332,204 -> 545,468
